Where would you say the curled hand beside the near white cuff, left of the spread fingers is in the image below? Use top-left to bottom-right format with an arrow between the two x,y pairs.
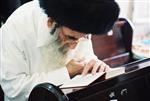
66,58 -> 85,77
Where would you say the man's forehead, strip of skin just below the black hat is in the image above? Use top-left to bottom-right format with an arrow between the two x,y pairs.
62,26 -> 87,38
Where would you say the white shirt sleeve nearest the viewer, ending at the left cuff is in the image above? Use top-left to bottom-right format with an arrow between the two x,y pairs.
0,21 -> 70,101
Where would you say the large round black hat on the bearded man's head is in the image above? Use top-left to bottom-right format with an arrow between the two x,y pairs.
39,0 -> 120,34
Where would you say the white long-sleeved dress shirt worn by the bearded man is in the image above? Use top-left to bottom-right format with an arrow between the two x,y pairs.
0,0 -> 96,101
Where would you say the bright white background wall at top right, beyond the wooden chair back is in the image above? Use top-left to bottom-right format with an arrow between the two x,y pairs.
116,0 -> 150,34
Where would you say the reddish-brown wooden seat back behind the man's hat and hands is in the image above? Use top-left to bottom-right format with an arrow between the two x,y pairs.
92,19 -> 133,67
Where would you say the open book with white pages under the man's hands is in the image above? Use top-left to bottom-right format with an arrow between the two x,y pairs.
60,67 -> 125,88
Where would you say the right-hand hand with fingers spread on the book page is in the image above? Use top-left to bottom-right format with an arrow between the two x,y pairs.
82,59 -> 111,75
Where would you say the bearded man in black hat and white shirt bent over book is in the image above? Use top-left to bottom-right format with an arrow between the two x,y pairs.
0,0 -> 119,101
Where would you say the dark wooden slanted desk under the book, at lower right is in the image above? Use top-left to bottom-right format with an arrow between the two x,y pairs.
65,58 -> 150,101
